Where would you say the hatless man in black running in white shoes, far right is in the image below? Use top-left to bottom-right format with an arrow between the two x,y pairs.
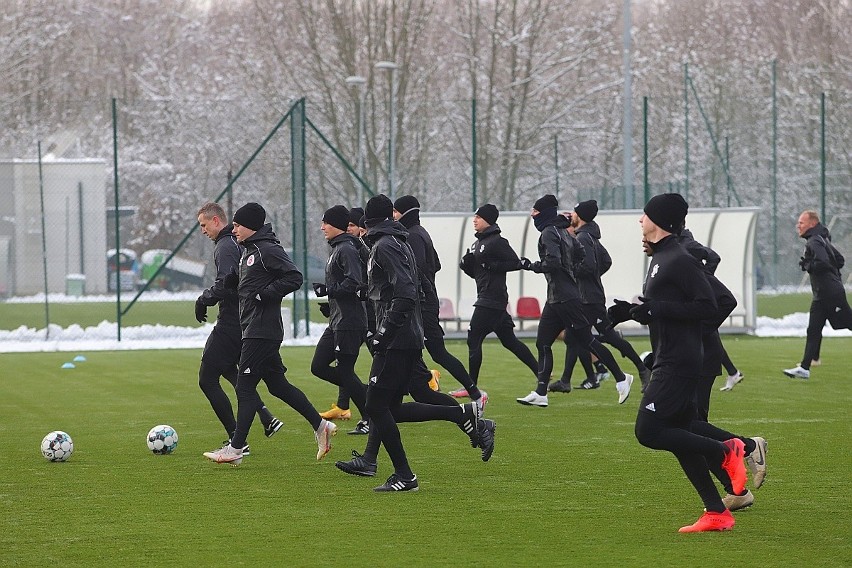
784,209 -> 852,379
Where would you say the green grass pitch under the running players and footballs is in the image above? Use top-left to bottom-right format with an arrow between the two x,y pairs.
0,337 -> 852,568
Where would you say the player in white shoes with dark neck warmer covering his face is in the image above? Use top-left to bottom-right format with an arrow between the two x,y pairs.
516,194 -> 633,407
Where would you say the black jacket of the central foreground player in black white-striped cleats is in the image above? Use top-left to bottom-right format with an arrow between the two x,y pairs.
366,219 -> 423,349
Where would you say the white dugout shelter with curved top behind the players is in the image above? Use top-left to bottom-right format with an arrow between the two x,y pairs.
421,208 -> 758,332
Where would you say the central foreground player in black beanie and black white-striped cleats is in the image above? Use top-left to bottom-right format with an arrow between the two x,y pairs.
336,195 -> 490,492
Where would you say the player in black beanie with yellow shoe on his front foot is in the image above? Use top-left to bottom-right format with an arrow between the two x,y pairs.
311,205 -> 367,432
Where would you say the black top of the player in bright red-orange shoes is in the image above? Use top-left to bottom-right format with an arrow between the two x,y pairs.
642,235 -> 719,379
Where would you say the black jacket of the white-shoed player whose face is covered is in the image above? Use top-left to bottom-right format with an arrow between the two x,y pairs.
531,215 -> 585,304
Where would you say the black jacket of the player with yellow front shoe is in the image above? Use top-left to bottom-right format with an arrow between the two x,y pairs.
325,233 -> 367,331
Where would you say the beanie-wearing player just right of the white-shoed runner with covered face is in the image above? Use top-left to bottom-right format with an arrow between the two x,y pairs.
548,199 -> 651,392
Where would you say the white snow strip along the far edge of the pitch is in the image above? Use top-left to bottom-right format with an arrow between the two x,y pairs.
0,292 -> 852,353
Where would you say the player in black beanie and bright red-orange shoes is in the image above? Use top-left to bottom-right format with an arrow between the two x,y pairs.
624,193 -> 747,532
